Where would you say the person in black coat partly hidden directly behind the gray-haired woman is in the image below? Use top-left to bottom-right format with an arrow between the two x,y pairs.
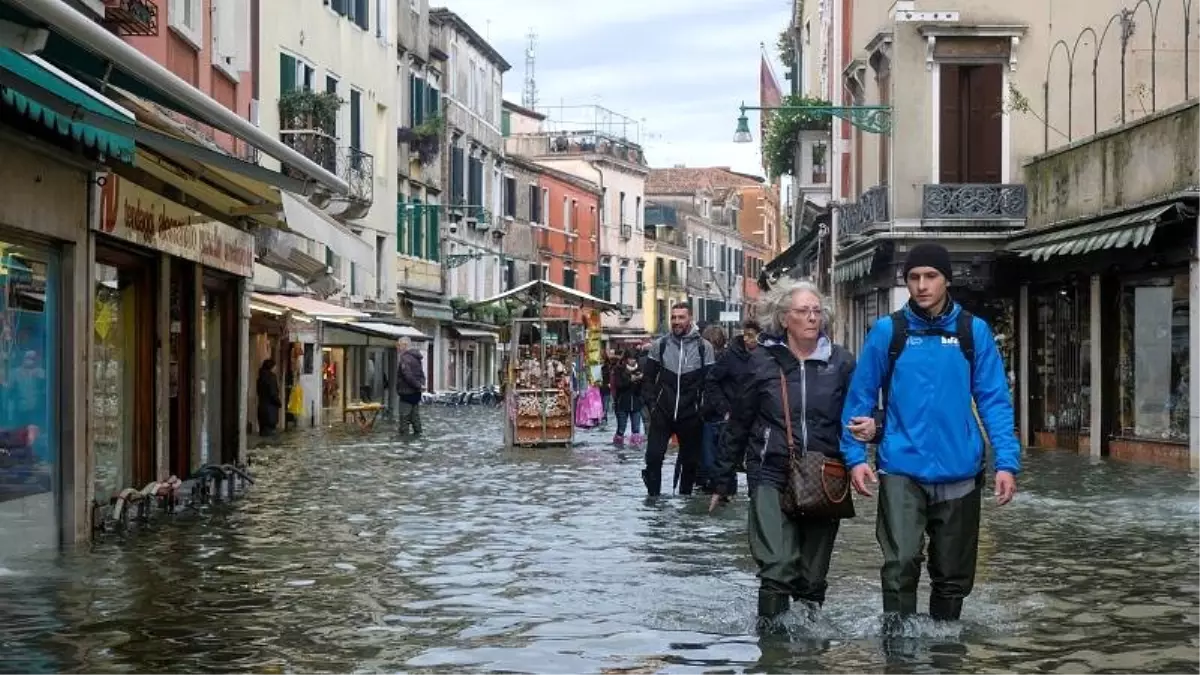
701,318 -> 762,496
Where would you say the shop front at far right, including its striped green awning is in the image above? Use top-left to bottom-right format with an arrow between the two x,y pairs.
1007,196 -> 1195,467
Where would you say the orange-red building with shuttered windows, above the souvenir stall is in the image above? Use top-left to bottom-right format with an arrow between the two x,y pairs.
534,166 -> 606,323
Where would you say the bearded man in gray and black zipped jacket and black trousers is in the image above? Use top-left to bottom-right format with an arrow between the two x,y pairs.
642,303 -> 715,497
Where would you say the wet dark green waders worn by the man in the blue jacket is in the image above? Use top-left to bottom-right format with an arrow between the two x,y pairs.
875,473 -> 983,621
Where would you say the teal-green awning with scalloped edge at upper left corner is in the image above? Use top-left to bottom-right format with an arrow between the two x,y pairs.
0,49 -> 136,163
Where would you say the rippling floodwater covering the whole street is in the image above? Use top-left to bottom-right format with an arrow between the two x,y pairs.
0,406 -> 1200,674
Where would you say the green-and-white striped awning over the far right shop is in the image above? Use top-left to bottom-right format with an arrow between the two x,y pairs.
1004,203 -> 1180,262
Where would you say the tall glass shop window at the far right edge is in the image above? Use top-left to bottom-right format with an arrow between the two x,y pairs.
1117,274 -> 1188,442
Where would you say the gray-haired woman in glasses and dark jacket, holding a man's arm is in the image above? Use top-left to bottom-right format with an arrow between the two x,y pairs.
710,281 -> 875,632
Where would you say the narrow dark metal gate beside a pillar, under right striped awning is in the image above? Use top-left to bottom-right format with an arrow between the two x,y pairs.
1050,285 -> 1087,450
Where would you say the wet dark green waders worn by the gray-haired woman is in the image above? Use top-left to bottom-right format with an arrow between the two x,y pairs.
748,484 -> 840,616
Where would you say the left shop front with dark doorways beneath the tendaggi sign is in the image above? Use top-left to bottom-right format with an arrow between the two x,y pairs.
91,174 -> 254,487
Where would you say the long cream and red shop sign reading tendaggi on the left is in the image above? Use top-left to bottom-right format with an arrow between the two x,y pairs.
92,173 -> 254,277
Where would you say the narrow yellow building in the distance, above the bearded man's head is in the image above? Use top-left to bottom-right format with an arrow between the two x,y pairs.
642,203 -> 688,335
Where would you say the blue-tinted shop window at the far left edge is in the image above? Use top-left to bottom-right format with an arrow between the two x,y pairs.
0,240 -> 59,554
